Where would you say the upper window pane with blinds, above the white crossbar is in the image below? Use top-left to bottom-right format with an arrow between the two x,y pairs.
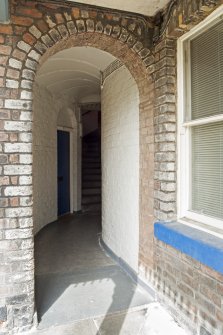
191,22 -> 223,120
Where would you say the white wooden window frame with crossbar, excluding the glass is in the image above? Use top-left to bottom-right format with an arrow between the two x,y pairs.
177,5 -> 223,238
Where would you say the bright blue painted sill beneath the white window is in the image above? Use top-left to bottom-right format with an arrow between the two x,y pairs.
154,222 -> 223,274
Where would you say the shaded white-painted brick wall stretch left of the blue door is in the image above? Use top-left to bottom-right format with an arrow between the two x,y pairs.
33,85 -> 57,233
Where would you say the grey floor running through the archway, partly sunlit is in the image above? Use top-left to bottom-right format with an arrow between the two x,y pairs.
35,214 -> 155,335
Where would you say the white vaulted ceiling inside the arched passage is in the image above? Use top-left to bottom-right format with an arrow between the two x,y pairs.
36,47 -> 116,103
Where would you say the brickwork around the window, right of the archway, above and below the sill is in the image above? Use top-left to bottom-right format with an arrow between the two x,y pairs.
152,0 -> 223,335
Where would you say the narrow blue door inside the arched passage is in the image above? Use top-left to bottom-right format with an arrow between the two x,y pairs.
57,130 -> 70,216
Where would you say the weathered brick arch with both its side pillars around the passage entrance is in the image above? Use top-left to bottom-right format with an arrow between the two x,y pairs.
0,0 -> 154,331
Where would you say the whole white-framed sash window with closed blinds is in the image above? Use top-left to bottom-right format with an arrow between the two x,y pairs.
178,6 -> 223,235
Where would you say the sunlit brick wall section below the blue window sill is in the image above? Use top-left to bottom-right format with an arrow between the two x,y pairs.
155,241 -> 223,335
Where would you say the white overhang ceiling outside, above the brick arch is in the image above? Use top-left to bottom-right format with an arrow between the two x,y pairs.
70,0 -> 170,16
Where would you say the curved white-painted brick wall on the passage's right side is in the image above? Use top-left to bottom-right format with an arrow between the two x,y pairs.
102,66 -> 139,271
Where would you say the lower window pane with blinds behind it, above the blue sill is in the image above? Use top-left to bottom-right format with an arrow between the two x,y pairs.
191,122 -> 223,219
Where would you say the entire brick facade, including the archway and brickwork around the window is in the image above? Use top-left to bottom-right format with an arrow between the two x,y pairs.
0,0 -> 223,334
